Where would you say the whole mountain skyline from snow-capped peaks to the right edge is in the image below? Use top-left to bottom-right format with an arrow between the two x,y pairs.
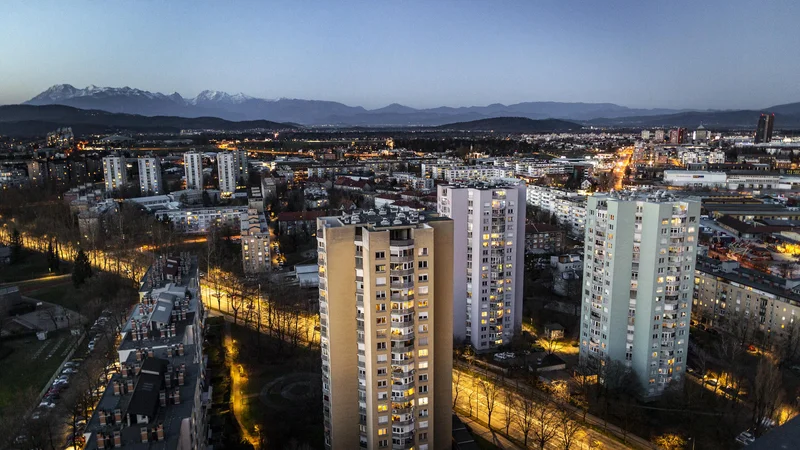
14,84 -> 800,128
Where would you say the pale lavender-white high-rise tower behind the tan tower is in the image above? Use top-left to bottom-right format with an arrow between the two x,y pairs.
438,178 -> 526,351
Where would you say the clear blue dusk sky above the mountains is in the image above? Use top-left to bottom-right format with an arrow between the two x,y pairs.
0,0 -> 800,109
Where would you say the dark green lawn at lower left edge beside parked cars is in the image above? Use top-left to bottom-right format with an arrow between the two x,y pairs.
0,332 -> 77,416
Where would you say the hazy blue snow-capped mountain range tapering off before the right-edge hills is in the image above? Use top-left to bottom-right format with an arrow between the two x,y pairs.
25,84 -> 680,126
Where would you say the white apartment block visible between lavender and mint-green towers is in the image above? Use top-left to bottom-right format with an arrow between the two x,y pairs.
526,184 -> 586,239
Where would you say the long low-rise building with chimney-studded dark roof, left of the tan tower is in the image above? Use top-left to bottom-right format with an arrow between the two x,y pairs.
84,256 -> 211,450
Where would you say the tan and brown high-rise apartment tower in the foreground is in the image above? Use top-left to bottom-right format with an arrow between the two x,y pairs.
317,207 -> 453,450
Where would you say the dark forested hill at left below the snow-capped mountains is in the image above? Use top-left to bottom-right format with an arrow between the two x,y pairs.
0,105 -> 294,136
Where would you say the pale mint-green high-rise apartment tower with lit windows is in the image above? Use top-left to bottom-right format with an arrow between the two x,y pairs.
580,191 -> 700,397
